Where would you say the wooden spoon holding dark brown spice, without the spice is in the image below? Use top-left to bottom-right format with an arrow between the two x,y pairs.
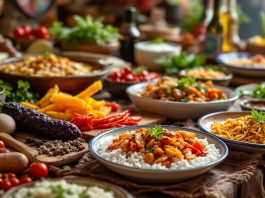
0,132 -> 88,166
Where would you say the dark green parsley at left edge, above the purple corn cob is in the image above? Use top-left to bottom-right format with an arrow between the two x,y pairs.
0,80 -> 39,103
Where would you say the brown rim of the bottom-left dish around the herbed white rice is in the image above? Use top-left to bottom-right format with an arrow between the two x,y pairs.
3,176 -> 133,198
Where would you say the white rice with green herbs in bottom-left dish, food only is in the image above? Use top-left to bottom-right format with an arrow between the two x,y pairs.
8,180 -> 114,198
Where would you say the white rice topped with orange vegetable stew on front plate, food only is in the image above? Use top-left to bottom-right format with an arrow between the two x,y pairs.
96,125 -> 221,170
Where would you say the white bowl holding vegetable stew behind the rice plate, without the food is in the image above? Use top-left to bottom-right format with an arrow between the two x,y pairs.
127,82 -> 239,120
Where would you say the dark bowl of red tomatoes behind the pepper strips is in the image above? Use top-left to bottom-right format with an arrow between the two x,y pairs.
104,66 -> 160,99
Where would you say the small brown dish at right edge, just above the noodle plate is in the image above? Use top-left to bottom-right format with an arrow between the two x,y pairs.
240,99 -> 265,112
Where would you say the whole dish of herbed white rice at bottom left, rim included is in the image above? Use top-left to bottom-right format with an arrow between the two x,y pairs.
3,177 -> 132,198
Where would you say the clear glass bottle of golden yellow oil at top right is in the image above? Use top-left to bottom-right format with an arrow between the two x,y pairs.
220,0 -> 240,52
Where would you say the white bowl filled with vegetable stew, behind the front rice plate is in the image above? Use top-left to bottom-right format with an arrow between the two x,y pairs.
127,76 -> 239,120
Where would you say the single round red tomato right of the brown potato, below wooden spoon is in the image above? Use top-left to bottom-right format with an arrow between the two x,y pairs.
29,162 -> 49,179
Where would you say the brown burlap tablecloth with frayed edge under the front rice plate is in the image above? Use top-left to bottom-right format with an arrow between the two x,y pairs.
50,120 -> 265,198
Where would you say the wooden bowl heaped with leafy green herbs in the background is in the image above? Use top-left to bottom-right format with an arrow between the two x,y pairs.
49,16 -> 119,54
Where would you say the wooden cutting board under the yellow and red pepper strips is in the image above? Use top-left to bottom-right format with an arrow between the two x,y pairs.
83,111 -> 166,141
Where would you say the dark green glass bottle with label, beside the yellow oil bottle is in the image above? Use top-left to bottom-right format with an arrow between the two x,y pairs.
204,0 -> 223,59
